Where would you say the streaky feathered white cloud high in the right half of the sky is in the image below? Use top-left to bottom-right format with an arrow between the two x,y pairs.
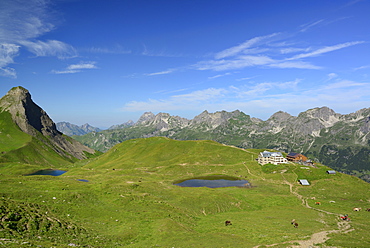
193,33 -> 364,71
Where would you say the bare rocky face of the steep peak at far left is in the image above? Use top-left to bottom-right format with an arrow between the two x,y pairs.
0,87 -> 95,159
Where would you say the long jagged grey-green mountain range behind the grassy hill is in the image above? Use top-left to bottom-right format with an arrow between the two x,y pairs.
76,107 -> 370,180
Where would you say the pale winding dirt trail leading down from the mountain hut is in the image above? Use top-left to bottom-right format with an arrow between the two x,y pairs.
243,162 -> 354,248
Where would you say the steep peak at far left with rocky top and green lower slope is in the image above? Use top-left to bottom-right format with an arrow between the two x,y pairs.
0,87 -> 96,164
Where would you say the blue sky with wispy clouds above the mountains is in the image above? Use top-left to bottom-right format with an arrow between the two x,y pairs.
0,0 -> 370,127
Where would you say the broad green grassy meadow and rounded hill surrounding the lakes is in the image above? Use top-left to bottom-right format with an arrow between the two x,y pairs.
0,137 -> 370,247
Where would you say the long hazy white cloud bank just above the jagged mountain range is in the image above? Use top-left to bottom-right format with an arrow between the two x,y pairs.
122,79 -> 370,119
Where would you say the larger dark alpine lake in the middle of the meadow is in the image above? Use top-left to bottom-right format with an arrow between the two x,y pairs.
173,175 -> 251,188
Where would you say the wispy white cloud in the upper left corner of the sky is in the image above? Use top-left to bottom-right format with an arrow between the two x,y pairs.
0,0 -> 77,77
